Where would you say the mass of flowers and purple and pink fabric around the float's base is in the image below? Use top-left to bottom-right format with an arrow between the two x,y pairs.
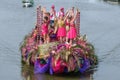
21,35 -> 98,74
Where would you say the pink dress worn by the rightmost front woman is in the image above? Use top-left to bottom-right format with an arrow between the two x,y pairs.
67,24 -> 77,39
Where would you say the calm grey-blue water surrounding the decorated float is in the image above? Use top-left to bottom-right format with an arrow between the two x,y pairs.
0,0 -> 120,80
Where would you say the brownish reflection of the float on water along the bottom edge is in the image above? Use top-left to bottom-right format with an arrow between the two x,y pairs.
21,65 -> 94,80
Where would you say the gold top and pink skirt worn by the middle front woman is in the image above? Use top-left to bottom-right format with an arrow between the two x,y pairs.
57,20 -> 66,37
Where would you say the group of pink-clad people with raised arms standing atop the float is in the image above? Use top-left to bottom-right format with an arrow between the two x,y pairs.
36,5 -> 78,45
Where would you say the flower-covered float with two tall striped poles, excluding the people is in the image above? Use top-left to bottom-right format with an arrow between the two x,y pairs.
20,6 -> 98,75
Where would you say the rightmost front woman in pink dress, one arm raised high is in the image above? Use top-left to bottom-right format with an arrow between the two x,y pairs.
67,10 -> 78,45
